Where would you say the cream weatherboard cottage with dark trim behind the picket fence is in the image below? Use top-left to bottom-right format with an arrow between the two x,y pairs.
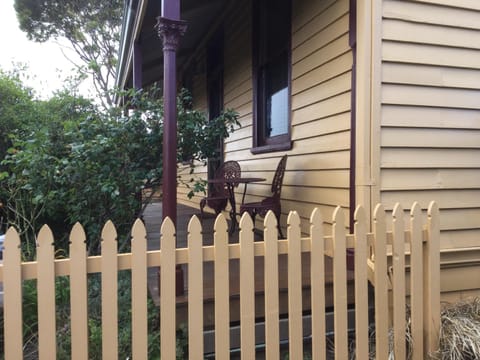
117,0 -> 480,297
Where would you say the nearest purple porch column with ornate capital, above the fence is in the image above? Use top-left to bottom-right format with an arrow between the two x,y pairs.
156,0 -> 187,225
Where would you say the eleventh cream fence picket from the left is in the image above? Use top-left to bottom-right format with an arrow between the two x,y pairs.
287,211 -> 303,359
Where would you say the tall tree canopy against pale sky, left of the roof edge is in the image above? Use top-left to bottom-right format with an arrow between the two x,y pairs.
15,0 -> 123,106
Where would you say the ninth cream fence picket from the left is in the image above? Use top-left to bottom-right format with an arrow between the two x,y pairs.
239,212 -> 255,360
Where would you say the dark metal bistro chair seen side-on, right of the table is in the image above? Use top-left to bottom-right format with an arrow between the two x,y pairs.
240,155 -> 287,238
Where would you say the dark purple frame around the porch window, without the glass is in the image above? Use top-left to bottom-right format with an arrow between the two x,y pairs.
251,0 -> 292,154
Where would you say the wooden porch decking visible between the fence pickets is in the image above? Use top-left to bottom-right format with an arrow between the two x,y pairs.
143,200 -> 354,325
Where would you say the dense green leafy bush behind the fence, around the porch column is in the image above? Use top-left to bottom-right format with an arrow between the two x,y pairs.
0,82 -> 238,259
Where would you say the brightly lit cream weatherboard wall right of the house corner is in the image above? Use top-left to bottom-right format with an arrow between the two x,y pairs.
379,0 -> 480,249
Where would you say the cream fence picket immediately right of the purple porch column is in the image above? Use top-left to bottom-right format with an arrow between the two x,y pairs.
188,216 -> 203,360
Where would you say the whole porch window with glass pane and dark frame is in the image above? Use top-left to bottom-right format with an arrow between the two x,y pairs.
252,0 -> 292,153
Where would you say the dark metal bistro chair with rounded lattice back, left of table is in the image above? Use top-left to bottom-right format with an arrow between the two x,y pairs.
200,161 -> 242,219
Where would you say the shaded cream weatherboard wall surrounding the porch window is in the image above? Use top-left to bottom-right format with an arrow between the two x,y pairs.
179,0 -> 352,233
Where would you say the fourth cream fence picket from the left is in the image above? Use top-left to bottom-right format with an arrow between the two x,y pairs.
101,221 -> 118,359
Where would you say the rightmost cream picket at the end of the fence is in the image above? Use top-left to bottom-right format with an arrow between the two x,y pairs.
424,201 -> 440,354
